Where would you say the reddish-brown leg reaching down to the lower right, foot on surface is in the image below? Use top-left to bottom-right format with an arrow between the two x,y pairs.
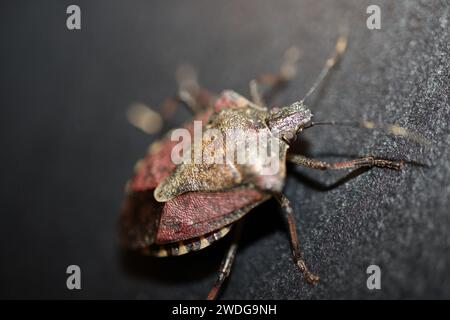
274,193 -> 319,284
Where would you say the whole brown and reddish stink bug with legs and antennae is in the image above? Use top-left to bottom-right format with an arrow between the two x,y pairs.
120,37 -> 419,299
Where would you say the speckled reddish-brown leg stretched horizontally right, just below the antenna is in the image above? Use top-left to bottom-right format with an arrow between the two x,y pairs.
287,154 -> 404,170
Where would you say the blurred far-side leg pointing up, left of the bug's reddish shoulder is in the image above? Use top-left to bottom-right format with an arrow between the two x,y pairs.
176,65 -> 214,115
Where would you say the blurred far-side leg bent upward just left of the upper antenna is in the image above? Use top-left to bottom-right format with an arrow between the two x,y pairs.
249,46 -> 300,107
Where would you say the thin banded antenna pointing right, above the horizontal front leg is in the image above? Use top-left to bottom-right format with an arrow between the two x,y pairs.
305,121 -> 431,147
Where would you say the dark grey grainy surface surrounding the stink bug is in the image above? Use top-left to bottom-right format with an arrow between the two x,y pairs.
0,0 -> 450,299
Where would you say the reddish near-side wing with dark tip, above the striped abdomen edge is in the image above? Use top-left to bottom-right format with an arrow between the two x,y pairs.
119,189 -> 270,249
